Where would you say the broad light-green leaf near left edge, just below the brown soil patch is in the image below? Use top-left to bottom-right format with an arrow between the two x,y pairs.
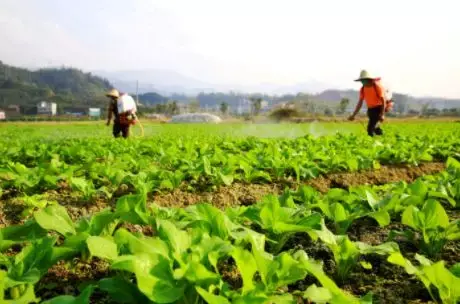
34,205 -> 77,236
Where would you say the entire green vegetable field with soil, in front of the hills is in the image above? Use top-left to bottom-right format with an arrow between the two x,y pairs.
0,122 -> 460,304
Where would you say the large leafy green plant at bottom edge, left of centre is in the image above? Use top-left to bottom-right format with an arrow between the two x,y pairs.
112,220 -> 232,303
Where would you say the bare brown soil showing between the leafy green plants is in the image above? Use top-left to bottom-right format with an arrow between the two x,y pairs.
0,163 -> 452,304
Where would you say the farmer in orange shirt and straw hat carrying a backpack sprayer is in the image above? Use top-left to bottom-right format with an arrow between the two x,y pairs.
348,70 -> 387,136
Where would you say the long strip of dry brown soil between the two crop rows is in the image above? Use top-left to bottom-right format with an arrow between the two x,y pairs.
153,163 -> 445,208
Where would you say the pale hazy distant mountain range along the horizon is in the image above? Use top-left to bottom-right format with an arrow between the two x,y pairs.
93,69 -> 460,109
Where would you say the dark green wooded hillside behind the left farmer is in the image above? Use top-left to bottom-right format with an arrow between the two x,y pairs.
0,61 -> 112,111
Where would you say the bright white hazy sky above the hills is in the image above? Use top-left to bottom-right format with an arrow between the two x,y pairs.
0,0 -> 460,98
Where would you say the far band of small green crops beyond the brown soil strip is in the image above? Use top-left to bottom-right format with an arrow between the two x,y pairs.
0,128 -> 460,199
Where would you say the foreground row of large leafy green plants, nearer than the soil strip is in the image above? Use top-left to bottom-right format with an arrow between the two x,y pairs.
0,158 -> 460,304
